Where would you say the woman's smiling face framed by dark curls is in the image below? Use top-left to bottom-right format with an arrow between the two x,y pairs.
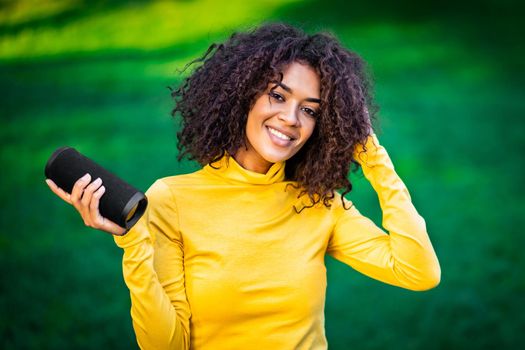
234,62 -> 320,173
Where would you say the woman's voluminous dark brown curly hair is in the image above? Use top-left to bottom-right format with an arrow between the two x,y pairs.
172,23 -> 377,211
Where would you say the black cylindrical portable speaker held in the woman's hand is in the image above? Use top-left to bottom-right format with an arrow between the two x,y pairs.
44,147 -> 148,230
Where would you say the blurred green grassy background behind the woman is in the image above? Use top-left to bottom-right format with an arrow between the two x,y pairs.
0,0 -> 525,349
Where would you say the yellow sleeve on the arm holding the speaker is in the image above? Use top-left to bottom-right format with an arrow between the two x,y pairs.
115,180 -> 190,349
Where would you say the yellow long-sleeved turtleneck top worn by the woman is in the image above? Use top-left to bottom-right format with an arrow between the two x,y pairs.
115,135 -> 440,350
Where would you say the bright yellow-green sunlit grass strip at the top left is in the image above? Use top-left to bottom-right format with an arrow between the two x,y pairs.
0,0 -> 296,59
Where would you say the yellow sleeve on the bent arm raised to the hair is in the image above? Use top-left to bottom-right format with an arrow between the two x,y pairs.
327,134 -> 441,290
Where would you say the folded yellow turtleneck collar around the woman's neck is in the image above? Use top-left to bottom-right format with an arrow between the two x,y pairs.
204,154 -> 285,185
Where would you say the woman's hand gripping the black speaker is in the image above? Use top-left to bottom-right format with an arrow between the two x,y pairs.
46,174 -> 126,236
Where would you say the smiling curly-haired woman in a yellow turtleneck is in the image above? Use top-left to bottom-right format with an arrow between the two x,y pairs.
48,24 -> 440,349
